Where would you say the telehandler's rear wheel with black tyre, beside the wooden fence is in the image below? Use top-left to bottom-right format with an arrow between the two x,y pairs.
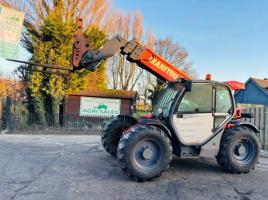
217,126 -> 260,174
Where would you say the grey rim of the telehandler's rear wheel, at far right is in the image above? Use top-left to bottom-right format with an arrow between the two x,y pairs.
233,139 -> 255,165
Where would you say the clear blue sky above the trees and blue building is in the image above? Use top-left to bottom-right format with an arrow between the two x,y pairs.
0,0 -> 268,82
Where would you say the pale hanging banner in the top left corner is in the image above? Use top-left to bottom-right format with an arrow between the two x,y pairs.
0,4 -> 24,59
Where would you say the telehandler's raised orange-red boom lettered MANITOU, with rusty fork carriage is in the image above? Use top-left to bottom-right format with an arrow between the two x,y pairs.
72,19 -> 192,81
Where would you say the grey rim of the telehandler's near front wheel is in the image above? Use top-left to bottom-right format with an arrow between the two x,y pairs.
133,139 -> 162,170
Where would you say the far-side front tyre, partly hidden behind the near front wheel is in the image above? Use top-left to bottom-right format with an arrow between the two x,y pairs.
101,116 -> 136,157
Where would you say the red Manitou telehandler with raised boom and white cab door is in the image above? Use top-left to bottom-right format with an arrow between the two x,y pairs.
8,19 -> 260,181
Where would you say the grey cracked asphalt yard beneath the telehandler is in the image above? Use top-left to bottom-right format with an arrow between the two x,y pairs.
0,135 -> 268,200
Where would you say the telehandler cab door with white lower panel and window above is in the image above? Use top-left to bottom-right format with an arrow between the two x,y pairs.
172,83 -> 215,145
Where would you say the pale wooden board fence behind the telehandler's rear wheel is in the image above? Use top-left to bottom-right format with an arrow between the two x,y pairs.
238,104 -> 268,150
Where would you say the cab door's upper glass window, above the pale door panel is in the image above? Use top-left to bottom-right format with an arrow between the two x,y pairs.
178,83 -> 213,113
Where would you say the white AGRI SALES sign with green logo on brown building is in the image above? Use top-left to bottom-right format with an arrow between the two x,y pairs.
80,97 -> 121,117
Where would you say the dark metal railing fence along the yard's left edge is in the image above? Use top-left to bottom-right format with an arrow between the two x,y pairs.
2,113 -> 112,134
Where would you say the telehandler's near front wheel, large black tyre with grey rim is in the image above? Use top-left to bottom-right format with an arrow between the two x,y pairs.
117,125 -> 172,181
